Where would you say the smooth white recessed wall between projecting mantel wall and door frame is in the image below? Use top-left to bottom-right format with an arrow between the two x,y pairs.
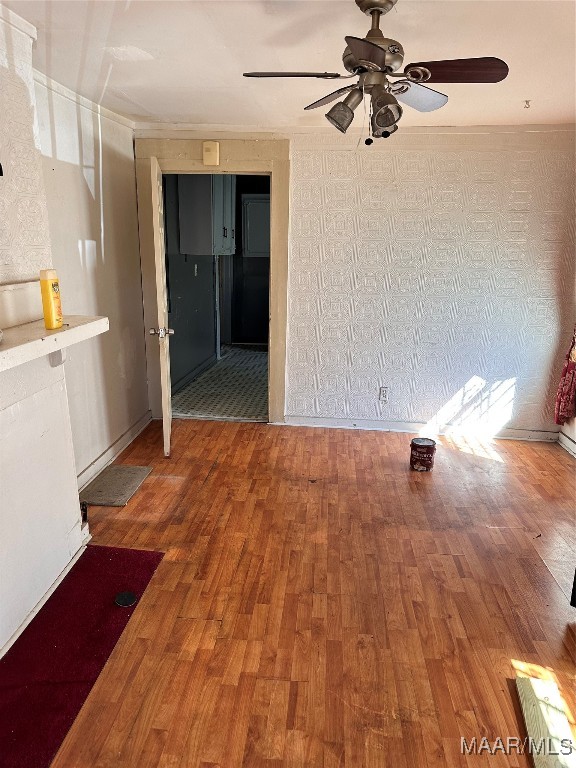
36,75 -> 149,485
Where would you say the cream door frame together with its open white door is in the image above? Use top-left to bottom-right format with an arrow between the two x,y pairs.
134,136 -> 290,457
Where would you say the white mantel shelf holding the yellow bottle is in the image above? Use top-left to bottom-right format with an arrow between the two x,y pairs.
0,315 -> 110,371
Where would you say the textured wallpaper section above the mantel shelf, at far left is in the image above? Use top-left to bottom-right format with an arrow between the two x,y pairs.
0,16 -> 52,284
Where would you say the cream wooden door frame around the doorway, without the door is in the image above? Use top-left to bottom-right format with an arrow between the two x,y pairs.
134,136 -> 290,424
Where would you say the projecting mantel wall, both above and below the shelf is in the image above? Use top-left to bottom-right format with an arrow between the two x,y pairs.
0,6 -> 84,655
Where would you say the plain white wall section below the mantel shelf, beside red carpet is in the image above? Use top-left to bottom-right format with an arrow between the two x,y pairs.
0,353 -> 87,656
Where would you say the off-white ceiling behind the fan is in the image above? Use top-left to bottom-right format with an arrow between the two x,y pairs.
4,0 -> 576,130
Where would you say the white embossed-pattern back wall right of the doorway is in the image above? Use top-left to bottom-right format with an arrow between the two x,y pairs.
287,126 -> 575,436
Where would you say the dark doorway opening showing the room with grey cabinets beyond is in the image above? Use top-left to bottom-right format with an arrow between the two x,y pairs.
163,174 -> 270,421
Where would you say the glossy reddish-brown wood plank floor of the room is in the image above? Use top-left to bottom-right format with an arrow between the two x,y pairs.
53,421 -> 576,768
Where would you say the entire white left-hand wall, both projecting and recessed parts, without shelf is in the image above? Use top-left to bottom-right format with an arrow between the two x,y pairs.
0,5 -> 149,655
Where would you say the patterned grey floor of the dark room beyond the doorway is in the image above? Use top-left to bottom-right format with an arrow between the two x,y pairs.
172,346 -> 268,421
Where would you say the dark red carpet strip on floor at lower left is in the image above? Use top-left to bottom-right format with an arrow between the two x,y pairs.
0,546 -> 163,768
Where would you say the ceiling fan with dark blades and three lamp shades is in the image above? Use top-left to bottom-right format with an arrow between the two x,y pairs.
244,0 -> 508,144
